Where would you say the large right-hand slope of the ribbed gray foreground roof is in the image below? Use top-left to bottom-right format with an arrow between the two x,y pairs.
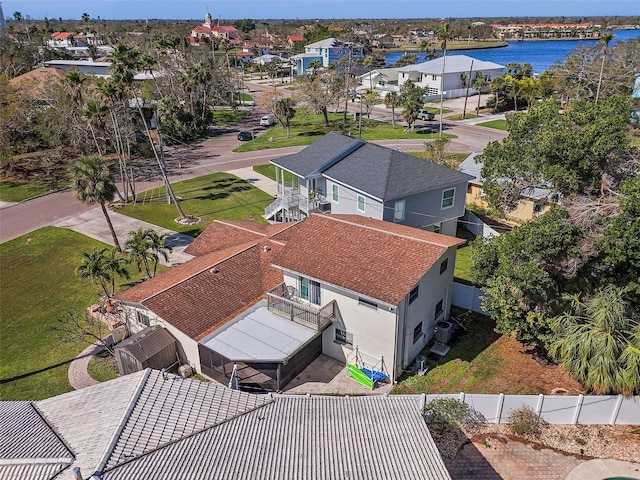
103,397 -> 450,480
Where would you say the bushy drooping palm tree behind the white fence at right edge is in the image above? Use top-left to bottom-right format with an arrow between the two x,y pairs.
549,285 -> 640,394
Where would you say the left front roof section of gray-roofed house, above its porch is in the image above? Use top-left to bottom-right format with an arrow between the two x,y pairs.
270,132 -> 364,177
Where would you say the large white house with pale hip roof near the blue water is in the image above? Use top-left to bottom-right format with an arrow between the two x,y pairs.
398,55 -> 505,100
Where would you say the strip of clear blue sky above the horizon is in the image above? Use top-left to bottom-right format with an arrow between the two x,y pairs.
2,0 -> 640,20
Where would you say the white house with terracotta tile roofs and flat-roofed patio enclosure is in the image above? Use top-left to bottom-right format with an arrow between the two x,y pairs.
115,214 -> 462,391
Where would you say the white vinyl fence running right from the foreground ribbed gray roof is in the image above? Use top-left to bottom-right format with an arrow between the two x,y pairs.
420,393 -> 640,425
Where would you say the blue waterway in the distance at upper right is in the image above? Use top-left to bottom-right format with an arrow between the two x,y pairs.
385,29 -> 640,74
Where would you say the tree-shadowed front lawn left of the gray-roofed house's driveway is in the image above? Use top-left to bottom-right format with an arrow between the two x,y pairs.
118,173 -> 273,237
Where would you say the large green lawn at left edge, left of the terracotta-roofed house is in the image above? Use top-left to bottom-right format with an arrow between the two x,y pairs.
0,227 -> 149,400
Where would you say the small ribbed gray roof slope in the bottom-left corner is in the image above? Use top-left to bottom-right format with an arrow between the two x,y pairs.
0,402 -> 73,464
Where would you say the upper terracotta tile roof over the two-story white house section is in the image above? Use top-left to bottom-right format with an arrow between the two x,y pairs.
273,214 -> 463,305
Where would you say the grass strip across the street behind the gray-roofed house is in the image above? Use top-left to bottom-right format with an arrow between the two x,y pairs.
234,113 -> 456,152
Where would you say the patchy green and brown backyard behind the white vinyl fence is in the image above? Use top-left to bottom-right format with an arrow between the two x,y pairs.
393,313 -> 584,395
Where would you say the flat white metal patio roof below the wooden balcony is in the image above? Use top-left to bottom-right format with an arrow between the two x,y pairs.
203,306 -> 318,361
